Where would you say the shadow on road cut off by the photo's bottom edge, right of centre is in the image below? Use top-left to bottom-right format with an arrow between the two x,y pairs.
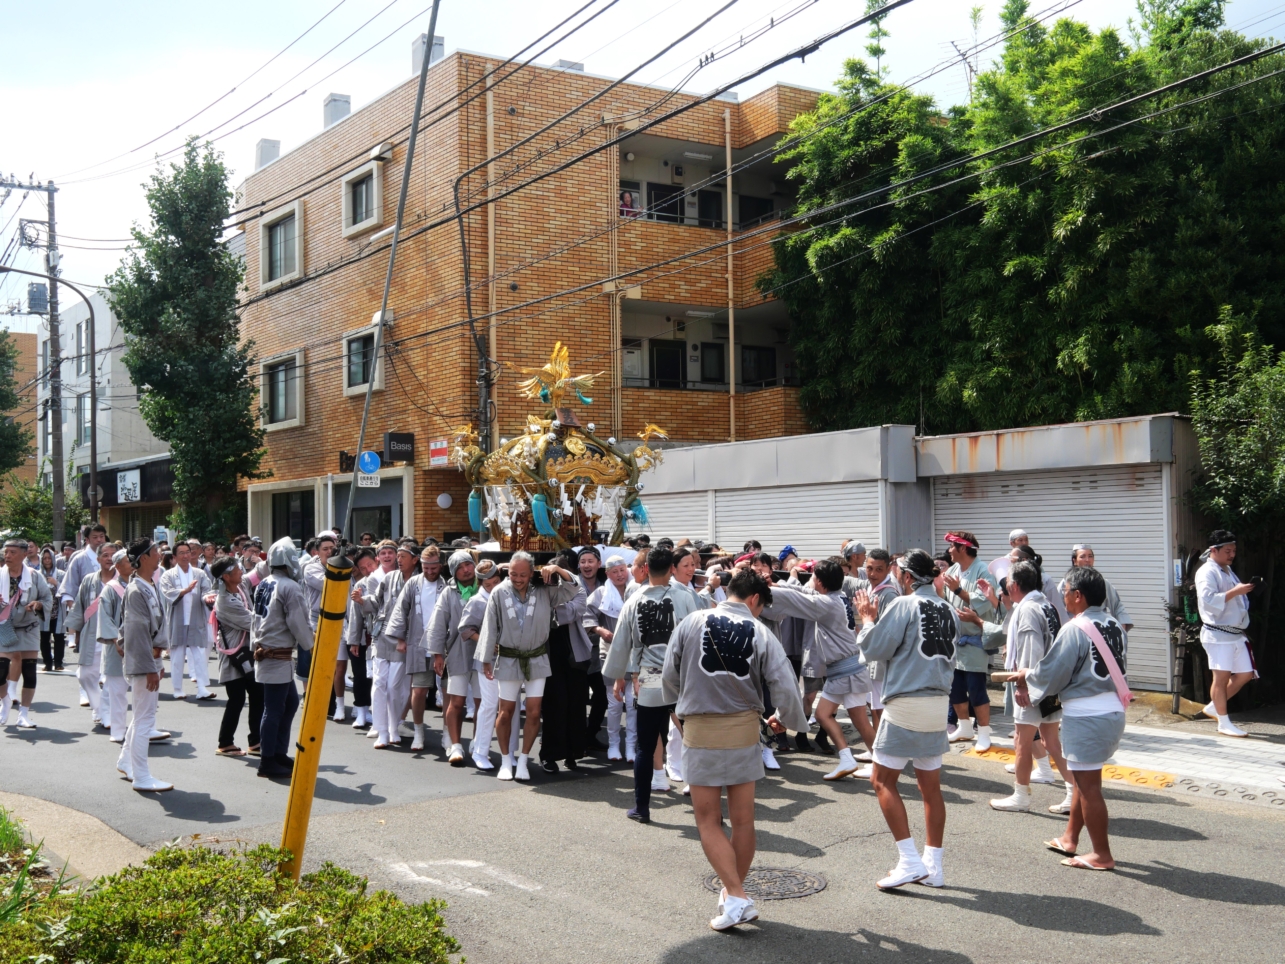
662,920 -> 973,964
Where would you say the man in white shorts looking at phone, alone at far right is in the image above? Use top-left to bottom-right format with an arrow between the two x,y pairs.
1196,528 -> 1258,736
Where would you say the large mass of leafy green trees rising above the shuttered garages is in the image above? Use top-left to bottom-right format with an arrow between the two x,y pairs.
759,0 -> 1285,432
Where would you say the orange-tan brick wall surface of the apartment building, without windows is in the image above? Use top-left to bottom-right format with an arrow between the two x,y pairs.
239,53 -> 815,537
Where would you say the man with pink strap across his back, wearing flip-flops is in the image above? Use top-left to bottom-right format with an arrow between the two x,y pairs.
1013,567 -> 1132,870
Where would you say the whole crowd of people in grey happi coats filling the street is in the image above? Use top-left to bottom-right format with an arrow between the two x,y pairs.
0,526 -> 1254,929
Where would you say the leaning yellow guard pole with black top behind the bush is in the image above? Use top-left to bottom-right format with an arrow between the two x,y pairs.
280,554 -> 352,880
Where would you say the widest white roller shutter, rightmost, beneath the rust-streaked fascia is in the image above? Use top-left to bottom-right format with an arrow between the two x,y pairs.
933,465 -> 1172,689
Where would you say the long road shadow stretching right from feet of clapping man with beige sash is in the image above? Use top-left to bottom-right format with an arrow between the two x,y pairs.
914,887 -> 1162,937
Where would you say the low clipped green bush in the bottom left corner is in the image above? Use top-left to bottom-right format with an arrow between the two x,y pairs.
0,846 -> 459,964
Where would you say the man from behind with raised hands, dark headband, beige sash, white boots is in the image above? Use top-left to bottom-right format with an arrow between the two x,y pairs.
856,549 -> 959,889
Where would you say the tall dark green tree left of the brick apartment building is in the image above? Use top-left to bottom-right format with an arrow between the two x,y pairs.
109,140 -> 263,539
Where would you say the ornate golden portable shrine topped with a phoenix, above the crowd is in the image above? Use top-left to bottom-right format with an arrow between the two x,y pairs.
451,342 -> 668,553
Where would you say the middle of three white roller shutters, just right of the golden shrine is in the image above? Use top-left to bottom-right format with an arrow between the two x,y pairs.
714,482 -> 879,559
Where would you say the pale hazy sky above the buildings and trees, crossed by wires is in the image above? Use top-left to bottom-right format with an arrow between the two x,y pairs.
0,0 -> 1285,330
